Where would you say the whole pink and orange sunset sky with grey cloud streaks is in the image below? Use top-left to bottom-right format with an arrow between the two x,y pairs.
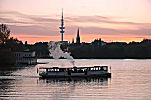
0,0 -> 151,43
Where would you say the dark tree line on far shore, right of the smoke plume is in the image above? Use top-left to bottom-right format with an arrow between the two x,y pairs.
69,39 -> 151,59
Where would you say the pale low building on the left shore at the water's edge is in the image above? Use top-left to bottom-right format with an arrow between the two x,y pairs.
14,50 -> 37,65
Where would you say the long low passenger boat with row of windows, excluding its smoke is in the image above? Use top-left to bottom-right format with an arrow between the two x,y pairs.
39,66 -> 111,78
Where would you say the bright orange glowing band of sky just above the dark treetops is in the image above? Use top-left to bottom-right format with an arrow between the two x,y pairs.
11,34 -> 151,44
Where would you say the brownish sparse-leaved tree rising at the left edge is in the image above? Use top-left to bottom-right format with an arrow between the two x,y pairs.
0,24 -> 10,44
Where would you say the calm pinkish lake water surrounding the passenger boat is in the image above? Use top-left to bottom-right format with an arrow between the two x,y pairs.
0,59 -> 151,100
